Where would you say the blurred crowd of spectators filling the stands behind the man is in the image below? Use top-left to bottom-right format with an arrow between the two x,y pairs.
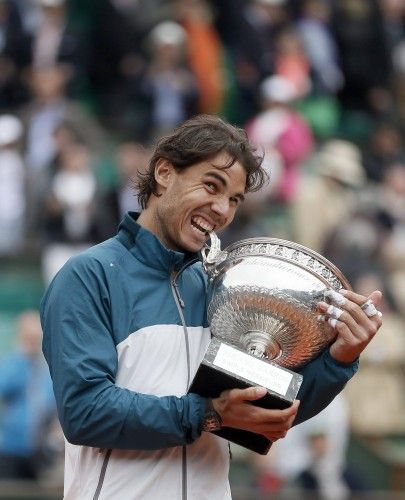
0,0 -> 405,500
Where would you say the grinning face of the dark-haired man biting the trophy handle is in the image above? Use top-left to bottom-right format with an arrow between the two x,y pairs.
150,153 -> 246,252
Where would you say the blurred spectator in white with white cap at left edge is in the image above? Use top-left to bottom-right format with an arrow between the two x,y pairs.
0,115 -> 26,256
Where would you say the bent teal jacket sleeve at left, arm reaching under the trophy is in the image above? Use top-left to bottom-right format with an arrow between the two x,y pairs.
41,256 -> 206,450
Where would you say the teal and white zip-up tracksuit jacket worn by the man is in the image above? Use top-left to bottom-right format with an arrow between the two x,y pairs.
41,213 -> 357,500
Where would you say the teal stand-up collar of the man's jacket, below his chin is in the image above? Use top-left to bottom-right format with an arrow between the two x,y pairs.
116,212 -> 198,275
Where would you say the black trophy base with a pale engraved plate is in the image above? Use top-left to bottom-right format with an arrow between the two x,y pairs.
188,337 -> 302,455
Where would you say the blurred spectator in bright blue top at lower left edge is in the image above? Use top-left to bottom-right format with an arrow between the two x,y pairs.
0,311 -> 56,479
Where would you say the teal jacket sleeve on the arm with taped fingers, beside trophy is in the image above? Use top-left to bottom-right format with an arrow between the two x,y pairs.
294,349 -> 358,425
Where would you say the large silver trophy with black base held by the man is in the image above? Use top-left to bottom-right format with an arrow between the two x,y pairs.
189,233 -> 351,454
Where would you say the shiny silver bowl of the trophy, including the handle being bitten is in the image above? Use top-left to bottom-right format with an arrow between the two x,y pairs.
202,234 -> 351,369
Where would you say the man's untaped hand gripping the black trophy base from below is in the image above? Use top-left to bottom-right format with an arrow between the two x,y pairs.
212,387 -> 300,441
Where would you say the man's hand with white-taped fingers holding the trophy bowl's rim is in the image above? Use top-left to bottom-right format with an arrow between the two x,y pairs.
318,290 -> 382,363
